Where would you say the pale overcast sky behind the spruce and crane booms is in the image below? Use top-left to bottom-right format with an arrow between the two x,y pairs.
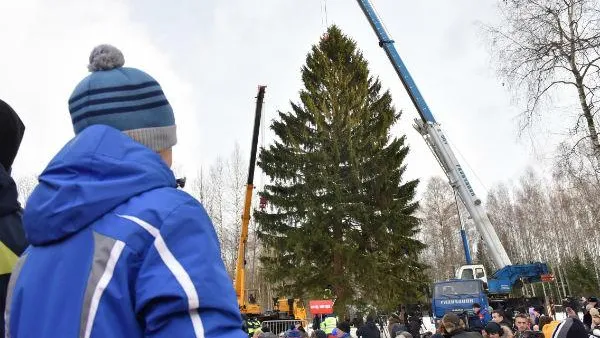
0,0 -> 554,197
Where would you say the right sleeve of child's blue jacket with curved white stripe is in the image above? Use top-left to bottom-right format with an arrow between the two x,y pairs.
135,197 -> 247,338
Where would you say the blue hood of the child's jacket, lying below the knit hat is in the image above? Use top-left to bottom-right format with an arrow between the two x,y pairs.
23,125 -> 177,245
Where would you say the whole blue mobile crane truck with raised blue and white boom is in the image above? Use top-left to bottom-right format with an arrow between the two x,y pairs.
357,0 -> 551,317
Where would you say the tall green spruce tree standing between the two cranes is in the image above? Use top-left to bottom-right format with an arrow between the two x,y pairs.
255,26 -> 426,313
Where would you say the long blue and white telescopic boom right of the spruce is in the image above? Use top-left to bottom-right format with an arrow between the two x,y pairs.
357,0 -> 511,269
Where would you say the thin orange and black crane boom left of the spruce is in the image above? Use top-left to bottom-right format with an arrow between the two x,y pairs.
234,86 -> 266,310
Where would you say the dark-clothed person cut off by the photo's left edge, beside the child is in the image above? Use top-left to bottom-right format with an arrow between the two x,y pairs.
0,100 -> 27,337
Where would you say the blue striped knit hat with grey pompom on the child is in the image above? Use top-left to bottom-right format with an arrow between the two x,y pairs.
69,45 -> 177,151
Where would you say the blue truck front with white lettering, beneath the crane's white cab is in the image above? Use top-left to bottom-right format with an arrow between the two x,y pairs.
431,279 -> 489,326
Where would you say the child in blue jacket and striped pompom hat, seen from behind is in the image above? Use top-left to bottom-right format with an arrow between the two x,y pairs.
5,45 -> 246,338
